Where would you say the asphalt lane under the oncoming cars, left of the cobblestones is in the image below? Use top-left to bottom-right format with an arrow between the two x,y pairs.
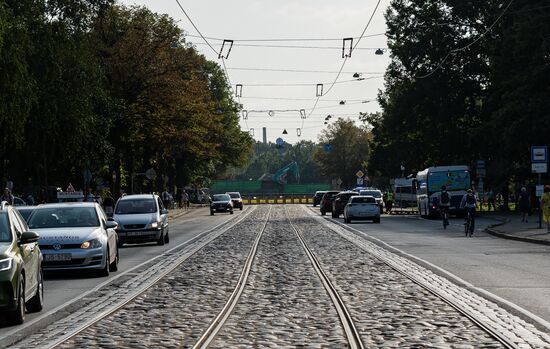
12,208 -> 246,332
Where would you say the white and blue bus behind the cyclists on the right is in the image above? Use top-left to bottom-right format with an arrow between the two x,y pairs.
416,166 -> 470,217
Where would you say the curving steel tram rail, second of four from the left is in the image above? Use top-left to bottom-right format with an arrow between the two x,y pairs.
193,205 -> 273,349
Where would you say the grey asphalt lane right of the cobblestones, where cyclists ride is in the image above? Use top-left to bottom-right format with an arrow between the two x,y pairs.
322,210 -> 550,322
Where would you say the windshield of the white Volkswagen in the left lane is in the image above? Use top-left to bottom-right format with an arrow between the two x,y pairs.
29,206 -> 99,229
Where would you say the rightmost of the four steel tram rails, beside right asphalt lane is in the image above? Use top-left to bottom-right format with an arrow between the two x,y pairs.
310,205 -> 520,349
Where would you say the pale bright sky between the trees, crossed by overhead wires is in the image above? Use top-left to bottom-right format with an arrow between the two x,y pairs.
120,0 -> 390,143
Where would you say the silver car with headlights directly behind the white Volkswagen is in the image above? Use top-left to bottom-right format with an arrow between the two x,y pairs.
113,194 -> 170,246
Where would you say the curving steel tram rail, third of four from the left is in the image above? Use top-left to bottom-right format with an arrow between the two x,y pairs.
285,206 -> 364,349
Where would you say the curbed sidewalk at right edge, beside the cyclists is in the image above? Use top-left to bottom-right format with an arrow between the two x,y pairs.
482,212 -> 550,245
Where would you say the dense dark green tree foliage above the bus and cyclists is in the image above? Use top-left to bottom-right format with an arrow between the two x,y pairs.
365,0 -> 550,190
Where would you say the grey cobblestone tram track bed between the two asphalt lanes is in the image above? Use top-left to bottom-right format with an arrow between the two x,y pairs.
7,206 -> 550,348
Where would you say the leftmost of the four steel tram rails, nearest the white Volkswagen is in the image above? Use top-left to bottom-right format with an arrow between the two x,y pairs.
41,209 -> 256,349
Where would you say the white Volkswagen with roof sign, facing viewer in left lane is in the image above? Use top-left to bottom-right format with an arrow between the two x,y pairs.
29,202 -> 118,276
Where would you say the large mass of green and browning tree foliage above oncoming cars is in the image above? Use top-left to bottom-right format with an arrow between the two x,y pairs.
0,0 -> 252,196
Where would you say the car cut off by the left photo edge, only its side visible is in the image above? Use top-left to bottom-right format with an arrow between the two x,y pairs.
0,202 -> 44,325
